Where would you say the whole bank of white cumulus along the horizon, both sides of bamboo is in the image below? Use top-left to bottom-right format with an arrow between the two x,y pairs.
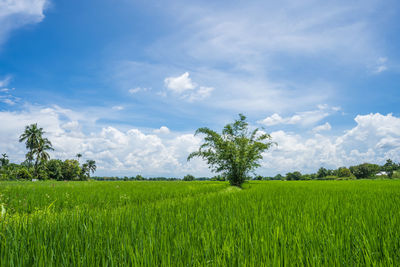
0,107 -> 400,176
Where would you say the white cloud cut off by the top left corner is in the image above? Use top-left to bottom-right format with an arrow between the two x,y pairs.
0,0 -> 48,44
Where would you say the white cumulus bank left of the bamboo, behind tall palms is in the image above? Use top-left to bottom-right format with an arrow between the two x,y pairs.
0,107 -> 209,176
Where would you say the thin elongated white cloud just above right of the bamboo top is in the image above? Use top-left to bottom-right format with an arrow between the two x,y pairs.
258,105 -> 340,126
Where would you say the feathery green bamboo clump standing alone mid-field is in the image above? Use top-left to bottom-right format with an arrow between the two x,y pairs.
187,114 -> 274,187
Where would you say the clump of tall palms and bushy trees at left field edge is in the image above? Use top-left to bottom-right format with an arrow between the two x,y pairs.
0,123 -> 96,181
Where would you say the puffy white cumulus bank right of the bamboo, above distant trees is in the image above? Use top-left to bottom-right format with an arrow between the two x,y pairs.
263,113 -> 400,173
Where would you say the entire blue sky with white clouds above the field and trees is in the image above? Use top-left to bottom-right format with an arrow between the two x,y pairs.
0,0 -> 400,177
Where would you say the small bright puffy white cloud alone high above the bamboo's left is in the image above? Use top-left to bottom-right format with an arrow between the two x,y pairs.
164,72 -> 214,102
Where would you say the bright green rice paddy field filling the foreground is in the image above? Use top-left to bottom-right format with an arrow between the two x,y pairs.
0,180 -> 400,266
